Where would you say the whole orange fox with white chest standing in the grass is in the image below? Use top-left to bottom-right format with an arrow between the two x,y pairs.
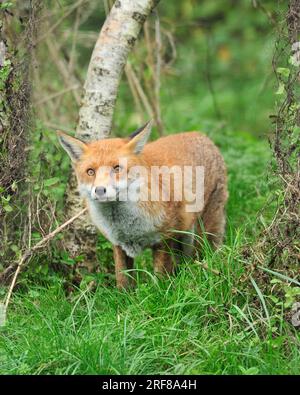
57,121 -> 228,288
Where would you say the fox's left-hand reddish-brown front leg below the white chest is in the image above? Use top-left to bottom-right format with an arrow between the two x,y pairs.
113,246 -> 133,289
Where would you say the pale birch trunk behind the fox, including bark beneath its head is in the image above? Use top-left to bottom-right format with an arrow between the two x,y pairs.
65,0 -> 159,270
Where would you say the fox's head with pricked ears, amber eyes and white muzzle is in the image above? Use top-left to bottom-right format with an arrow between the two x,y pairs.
57,121 -> 152,202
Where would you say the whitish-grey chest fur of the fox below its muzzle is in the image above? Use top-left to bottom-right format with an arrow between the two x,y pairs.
89,200 -> 162,257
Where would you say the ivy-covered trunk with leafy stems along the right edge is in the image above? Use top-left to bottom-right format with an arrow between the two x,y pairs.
247,1 -> 300,277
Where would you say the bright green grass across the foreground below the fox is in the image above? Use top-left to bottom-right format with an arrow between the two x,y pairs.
0,251 -> 300,374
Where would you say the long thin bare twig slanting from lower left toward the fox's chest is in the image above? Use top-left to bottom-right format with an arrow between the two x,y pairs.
4,208 -> 87,310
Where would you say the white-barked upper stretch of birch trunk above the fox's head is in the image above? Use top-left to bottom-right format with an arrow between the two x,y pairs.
76,0 -> 159,141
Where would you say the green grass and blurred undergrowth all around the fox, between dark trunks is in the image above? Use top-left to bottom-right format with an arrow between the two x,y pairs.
0,0 -> 300,374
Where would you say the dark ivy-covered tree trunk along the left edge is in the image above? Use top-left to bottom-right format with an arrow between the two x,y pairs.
0,0 -> 41,276
